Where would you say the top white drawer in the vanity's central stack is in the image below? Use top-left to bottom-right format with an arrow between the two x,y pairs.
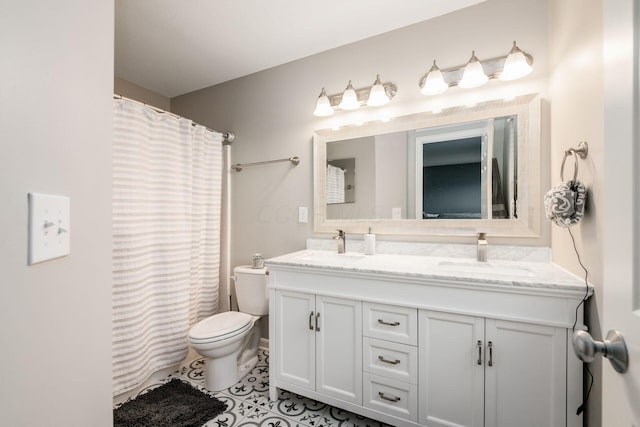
362,303 -> 418,345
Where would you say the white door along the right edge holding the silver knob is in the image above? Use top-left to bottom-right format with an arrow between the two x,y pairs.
594,0 -> 640,427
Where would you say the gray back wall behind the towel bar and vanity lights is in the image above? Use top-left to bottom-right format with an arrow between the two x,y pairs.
171,0 -> 548,284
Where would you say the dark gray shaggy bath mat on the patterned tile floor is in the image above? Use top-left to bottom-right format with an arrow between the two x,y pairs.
113,378 -> 227,427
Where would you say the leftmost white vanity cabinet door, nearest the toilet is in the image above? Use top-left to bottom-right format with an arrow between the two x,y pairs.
272,291 -> 316,390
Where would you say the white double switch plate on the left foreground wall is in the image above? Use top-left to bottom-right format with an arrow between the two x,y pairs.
29,193 -> 71,264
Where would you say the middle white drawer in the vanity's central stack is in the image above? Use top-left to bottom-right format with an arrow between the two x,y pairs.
362,338 -> 418,384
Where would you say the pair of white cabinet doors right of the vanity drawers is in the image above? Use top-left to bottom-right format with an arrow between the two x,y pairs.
418,310 -> 567,427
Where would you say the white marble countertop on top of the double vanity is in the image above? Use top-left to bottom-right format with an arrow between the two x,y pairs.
265,249 -> 593,294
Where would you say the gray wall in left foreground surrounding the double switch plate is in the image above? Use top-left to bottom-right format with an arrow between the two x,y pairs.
0,0 -> 114,427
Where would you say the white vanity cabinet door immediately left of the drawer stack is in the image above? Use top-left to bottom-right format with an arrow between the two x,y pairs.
316,296 -> 362,405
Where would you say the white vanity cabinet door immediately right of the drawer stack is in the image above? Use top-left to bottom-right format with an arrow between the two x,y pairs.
418,310 -> 482,427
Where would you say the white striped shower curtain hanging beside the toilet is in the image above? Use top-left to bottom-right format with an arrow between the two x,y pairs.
112,99 -> 222,395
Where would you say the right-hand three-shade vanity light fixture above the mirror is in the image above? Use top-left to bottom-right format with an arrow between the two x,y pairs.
420,41 -> 533,95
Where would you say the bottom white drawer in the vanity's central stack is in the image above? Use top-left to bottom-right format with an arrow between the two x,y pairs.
363,372 -> 418,422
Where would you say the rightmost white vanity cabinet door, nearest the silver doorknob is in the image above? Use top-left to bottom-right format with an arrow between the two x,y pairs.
485,319 -> 567,427
